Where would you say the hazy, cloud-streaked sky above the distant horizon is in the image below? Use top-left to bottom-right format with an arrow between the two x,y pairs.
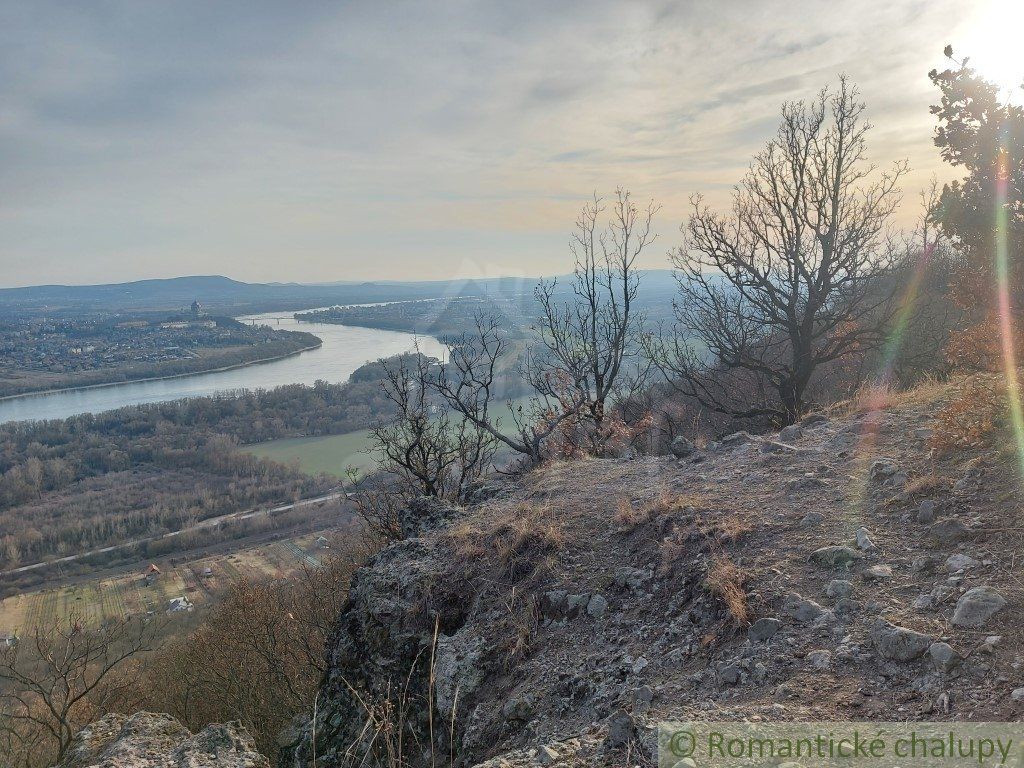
0,0 -> 1024,287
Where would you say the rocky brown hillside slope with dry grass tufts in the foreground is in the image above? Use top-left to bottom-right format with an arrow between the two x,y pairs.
292,384 -> 1024,768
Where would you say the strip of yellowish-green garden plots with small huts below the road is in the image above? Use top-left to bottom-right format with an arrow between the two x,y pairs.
0,534 -> 330,637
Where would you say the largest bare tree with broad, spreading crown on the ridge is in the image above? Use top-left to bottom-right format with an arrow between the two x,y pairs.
650,78 -> 906,425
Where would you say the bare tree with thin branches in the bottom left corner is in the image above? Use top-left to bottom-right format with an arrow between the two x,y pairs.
0,615 -> 153,762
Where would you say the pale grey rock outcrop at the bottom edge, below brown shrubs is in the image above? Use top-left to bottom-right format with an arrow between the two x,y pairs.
60,712 -> 270,768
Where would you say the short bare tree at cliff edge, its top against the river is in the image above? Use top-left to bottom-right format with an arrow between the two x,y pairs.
371,349 -> 497,501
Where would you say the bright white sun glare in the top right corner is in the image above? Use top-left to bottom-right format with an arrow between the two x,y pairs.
953,0 -> 1024,102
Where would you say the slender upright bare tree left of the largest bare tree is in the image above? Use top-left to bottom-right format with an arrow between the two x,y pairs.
536,187 -> 659,434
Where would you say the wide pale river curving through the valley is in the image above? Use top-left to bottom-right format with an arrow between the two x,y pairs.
0,312 -> 441,423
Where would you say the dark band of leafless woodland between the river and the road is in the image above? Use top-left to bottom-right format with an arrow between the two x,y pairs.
0,364 -> 405,570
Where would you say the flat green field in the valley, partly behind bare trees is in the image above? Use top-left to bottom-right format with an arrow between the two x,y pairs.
245,397 -> 528,478
